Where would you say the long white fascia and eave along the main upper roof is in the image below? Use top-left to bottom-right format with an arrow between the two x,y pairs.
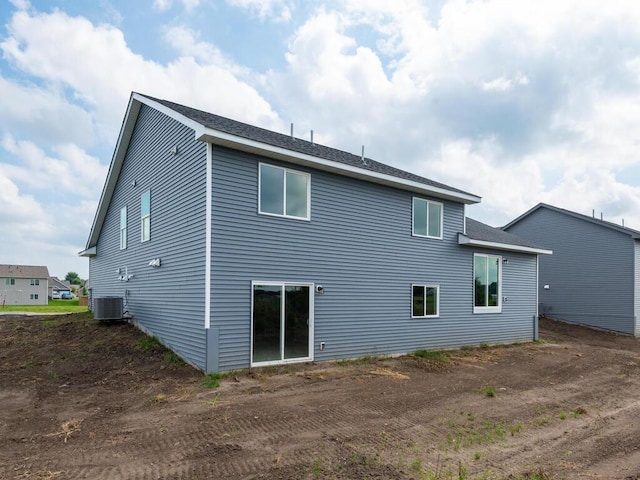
196,126 -> 480,204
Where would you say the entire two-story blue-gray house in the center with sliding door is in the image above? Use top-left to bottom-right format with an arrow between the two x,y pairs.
81,93 -> 550,372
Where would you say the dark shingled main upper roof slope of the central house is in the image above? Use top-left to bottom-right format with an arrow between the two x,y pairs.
144,94 -> 473,195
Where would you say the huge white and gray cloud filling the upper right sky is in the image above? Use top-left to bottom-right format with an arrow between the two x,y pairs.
272,0 -> 640,228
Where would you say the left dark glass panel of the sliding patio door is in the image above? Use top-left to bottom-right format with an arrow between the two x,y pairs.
253,285 -> 282,362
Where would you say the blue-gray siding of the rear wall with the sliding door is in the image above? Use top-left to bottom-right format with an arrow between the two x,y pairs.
210,146 -> 536,370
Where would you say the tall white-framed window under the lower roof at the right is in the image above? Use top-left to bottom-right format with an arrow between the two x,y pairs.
473,253 -> 502,313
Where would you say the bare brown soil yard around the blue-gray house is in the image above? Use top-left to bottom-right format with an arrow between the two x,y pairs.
0,314 -> 640,480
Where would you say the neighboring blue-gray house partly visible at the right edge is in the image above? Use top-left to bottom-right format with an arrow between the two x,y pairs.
503,203 -> 640,336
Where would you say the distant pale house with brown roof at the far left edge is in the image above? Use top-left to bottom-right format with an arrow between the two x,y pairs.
0,265 -> 49,307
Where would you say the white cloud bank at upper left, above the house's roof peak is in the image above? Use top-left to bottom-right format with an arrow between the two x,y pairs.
0,11 -> 277,138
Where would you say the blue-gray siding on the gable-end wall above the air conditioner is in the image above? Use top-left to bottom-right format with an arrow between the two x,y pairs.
90,106 -> 206,368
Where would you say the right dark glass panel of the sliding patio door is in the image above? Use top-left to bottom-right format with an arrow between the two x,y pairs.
284,286 -> 309,359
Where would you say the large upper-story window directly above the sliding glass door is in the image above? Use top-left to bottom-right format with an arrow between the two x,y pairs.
258,163 -> 311,220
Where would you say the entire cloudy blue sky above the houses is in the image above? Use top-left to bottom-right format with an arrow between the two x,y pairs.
0,0 -> 640,278
